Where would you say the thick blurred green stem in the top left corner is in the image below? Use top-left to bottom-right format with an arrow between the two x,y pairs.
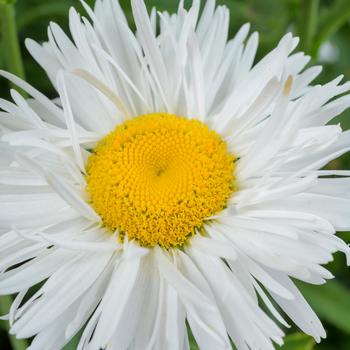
0,4 -> 25,93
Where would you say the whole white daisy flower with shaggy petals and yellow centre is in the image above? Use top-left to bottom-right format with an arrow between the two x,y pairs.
0,0 -> 350,350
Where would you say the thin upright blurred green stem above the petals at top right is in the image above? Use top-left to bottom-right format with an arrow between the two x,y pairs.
299,0 -> 320,54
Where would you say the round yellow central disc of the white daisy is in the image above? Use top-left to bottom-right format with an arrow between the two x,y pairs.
87,113 -> 235,248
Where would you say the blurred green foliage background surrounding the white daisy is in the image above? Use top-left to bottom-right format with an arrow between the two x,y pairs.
0,0 -> 350,350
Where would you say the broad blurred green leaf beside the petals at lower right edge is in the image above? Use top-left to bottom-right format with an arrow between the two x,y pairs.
297,280 -> 350,333
